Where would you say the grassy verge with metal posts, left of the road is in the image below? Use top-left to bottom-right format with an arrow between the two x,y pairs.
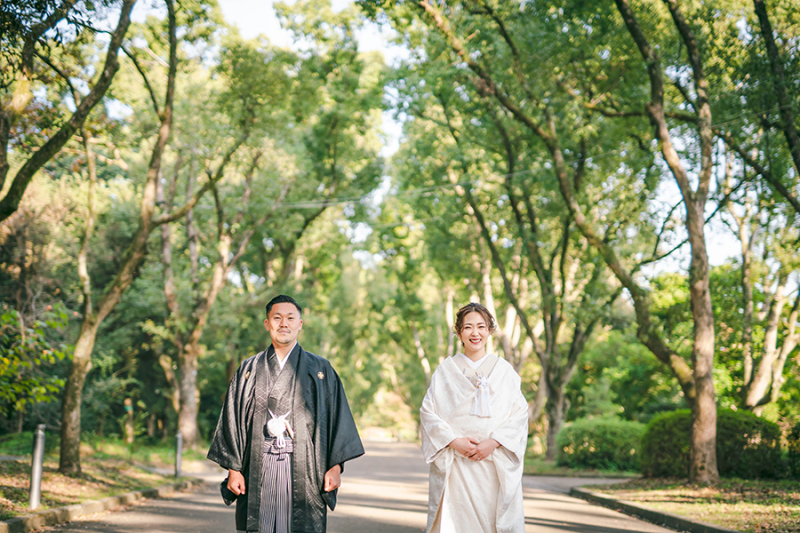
0,432 -> 204,520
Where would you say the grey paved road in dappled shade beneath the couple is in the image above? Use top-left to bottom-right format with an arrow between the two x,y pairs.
51,442 -> 670,533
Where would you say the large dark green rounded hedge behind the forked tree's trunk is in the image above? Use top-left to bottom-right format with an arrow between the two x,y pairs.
642,409 -> 783,479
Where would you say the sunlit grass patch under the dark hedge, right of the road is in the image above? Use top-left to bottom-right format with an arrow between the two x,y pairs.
587,479 -> 800,533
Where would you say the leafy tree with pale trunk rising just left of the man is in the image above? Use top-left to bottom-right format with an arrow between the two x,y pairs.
153,2 -> 388,445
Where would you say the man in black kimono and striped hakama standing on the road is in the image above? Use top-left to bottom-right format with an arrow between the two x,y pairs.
208,295 -> 364,533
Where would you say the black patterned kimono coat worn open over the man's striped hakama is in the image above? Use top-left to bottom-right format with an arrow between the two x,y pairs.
208,344 -> 364,533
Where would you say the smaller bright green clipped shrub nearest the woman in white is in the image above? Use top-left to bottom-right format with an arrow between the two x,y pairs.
556,418 -> 645,470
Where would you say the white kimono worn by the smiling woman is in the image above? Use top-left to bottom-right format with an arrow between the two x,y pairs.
420,354 -> 528,533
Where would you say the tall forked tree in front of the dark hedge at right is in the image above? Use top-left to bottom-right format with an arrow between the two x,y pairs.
367,0 -> 732,483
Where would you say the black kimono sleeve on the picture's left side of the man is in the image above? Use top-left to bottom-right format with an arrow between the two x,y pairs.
207,364 -> 247,472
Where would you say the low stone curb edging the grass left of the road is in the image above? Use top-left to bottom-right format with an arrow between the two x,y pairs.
0,478 -> 205,533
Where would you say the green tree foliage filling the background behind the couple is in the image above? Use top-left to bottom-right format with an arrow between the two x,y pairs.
0,0 -> 800,476
